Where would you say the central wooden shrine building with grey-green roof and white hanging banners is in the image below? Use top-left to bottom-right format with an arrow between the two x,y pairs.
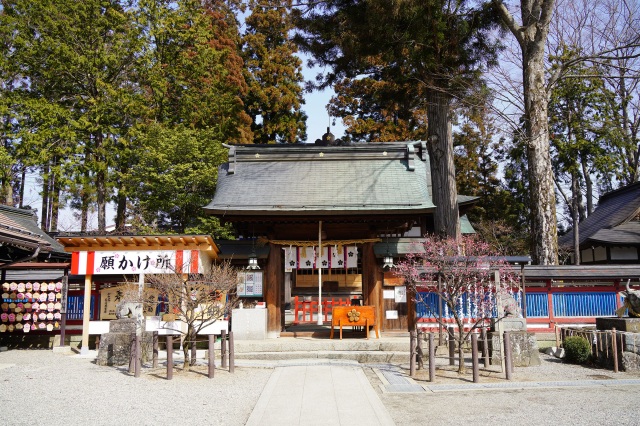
205,140 -> 475,337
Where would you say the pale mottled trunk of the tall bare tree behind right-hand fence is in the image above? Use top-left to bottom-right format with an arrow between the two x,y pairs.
522,35 -> 558,265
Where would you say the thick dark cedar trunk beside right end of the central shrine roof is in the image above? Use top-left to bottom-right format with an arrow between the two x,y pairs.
427,90 -> 460,239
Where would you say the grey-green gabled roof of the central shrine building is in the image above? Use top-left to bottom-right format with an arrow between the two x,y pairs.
205,142 -> 472,215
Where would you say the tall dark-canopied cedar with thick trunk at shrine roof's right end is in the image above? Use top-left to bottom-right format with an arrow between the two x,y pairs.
296,0 -> 494,237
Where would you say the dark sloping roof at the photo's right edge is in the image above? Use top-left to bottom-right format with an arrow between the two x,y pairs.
558,182 -> 640,246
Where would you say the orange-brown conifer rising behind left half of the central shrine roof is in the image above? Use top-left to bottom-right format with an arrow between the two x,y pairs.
243,0 -> 307,143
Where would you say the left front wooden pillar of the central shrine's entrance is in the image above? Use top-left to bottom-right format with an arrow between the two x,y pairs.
263,244 -> 284,338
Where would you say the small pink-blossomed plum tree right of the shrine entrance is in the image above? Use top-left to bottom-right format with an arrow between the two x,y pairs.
395,235 -> 519,374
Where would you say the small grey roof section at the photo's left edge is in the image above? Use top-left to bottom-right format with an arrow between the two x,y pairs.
0,205 -> 64,253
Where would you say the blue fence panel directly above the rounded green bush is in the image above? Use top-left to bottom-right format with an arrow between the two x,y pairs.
551,292 -> 617,317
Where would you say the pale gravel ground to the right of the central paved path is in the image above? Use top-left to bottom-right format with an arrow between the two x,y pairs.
365,355 -> 640,426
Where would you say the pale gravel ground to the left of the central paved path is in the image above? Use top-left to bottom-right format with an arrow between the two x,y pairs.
0,350 -> 273,426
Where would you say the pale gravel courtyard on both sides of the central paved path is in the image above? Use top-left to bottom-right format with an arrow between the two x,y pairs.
0,350 -> 640,426
